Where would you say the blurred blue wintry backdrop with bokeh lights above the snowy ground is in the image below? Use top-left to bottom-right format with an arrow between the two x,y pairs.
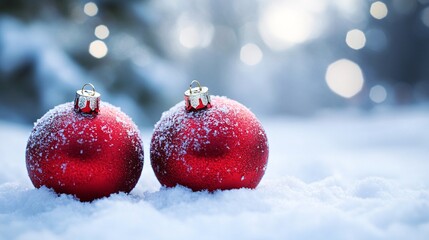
0,0 -> 429,125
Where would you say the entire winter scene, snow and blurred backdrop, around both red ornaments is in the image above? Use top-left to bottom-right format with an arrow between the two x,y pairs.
0,0 -> 429,239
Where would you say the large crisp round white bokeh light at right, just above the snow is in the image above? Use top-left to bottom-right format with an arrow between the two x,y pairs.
325,59 -> 364,98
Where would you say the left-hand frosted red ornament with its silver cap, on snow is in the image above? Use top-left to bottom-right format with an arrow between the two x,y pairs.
26,85 -> 143,201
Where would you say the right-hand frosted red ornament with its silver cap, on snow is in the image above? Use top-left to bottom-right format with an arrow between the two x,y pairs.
150,80 -> 268,191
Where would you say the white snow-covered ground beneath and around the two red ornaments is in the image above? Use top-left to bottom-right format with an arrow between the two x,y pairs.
0,108 -> 429,239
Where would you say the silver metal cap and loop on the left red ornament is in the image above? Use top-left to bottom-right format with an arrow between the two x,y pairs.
74,83 -> 100,115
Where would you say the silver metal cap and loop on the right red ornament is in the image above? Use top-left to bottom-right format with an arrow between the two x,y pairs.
185,80 -> 211,111
